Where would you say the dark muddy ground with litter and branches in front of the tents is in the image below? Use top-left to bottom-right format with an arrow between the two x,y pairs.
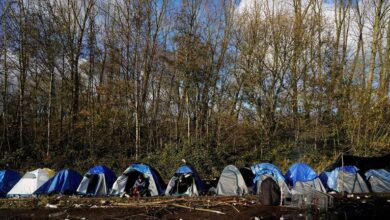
0,195 -> 390,220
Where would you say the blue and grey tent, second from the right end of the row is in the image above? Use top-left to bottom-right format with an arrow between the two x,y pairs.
320,166 -> 369,193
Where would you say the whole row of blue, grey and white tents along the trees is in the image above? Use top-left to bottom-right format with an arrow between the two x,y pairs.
0,160 -> 390,198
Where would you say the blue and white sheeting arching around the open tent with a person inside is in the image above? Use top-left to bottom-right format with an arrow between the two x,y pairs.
111,163 -> 165,196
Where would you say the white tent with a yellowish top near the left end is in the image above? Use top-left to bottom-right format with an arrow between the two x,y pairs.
7,168 -> 55,197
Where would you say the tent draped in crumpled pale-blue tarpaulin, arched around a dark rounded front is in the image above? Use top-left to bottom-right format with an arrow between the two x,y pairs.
251,163 -> 290,197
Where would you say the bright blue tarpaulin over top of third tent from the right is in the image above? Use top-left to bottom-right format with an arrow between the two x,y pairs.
285,163 -> 318,186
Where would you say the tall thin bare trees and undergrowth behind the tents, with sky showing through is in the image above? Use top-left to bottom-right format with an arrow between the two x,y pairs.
0,0 -> 390,176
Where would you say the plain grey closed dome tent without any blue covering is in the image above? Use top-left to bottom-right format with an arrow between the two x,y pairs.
217,165 -> 248,196
